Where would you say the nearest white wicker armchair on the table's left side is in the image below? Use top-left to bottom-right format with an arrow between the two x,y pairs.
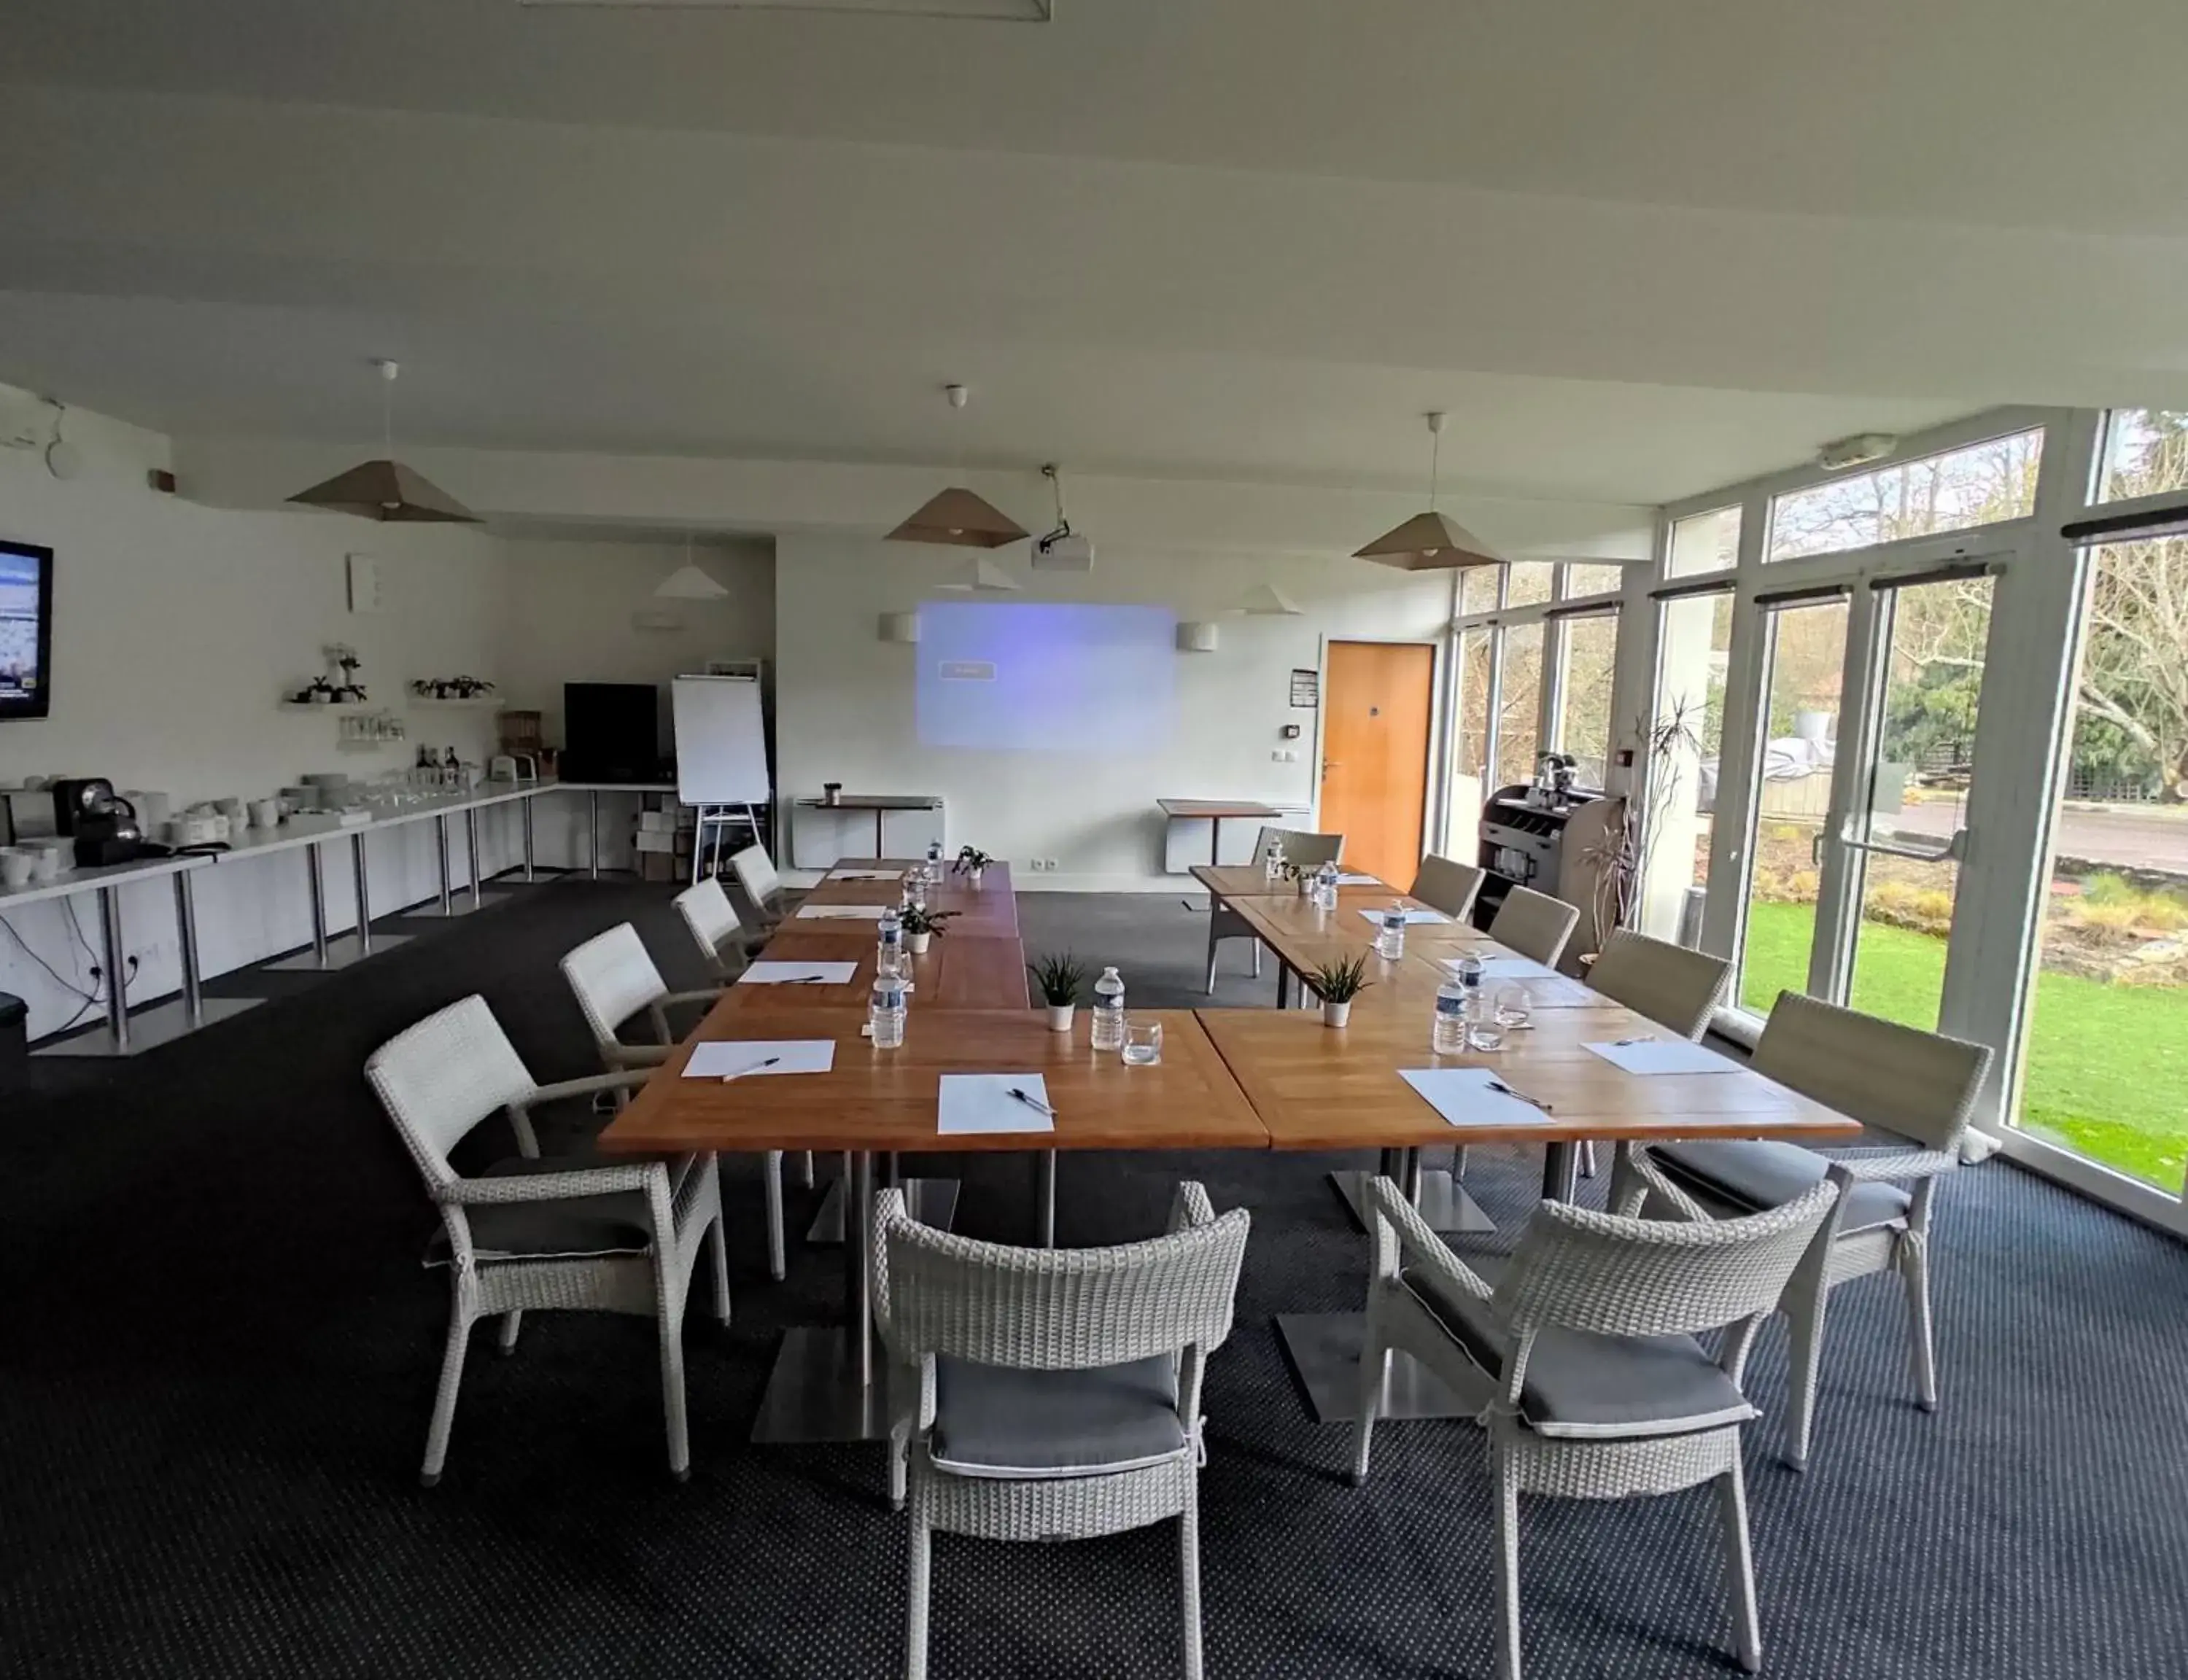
365,998 -> 729,1488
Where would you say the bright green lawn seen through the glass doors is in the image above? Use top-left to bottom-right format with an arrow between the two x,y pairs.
1739,903 -> 2188,1190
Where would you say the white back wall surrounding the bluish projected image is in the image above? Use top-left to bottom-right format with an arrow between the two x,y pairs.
775,536 -> 1451,890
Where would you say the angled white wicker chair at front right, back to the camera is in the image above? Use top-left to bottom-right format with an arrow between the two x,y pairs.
1352,1164 -> 1838,1680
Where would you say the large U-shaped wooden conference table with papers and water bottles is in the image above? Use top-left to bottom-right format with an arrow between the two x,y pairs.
600,864 -> 1862,1442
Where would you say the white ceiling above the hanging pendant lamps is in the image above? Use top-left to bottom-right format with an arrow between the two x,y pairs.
0,0 -> 2188,503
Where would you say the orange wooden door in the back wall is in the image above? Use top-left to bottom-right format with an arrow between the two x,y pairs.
1319,641 -> 1435,886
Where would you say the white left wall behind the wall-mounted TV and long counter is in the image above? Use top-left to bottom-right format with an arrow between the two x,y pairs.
0,387 -> 508,1032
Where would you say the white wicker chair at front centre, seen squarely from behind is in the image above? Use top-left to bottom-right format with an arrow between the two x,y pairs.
873,1183 -> 1249,1680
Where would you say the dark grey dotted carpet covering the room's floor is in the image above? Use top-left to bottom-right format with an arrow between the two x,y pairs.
0,882 -> 2188,1680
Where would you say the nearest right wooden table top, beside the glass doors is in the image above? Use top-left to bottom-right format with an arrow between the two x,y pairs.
1201,1004 -> 1862,1148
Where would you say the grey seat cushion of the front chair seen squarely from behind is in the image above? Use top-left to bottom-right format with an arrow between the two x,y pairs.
928,1354 -> 1186,1479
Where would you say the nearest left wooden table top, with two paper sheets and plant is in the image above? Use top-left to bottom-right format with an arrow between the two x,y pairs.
600,1006 -> 1269,1155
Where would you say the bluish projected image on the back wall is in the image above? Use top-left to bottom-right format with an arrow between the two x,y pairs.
917,602 -> 1177,752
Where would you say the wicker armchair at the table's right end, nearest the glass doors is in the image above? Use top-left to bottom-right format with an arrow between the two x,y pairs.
1610,991 -> 1991,1470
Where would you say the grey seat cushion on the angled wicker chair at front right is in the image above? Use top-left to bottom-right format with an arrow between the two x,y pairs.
1403,1256 -> 1755,1442
